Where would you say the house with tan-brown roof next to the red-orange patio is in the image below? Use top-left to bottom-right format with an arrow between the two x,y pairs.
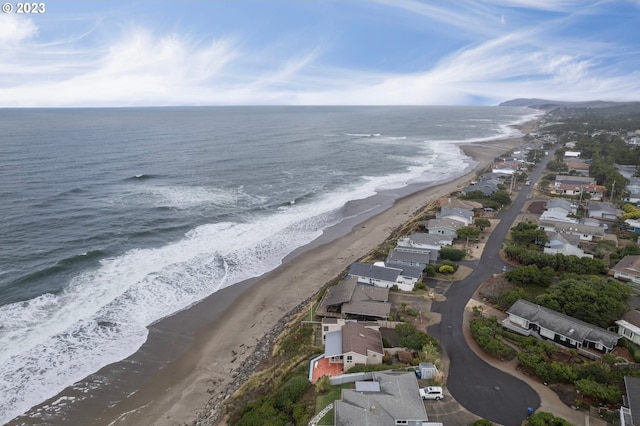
324,321 -> 384,372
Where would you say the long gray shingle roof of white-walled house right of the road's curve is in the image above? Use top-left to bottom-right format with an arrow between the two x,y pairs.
507,299 -> 620,349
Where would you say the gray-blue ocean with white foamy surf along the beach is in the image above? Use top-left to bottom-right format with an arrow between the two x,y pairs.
0,107 -> 535,423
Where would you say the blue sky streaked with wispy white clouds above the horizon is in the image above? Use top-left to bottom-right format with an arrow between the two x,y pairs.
0,0 -> 640,107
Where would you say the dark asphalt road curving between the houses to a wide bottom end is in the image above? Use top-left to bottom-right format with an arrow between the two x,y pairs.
429,148 -> 553,426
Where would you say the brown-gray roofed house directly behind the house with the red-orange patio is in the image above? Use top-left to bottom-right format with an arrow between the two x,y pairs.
315,277 -> 391,320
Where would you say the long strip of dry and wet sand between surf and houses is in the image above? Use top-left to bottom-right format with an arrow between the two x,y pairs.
10,120 -> 537,425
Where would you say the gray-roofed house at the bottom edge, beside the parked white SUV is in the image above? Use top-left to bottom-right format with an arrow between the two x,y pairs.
333,372 -> 429,426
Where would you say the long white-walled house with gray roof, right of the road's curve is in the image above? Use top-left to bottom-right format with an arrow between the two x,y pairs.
502,299 -> 620,354
